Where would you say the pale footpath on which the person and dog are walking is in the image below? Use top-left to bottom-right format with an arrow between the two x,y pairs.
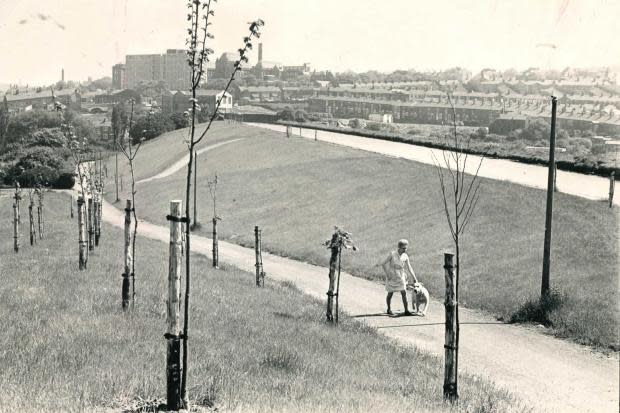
103,139 -> 619,413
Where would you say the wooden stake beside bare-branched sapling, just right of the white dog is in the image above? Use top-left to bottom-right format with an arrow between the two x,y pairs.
443,253 -> 459,402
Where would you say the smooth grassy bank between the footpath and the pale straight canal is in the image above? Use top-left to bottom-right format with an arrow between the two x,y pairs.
108,123 -> 619,349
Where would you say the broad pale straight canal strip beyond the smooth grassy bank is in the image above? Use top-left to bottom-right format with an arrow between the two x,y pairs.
250,123 -> 620,205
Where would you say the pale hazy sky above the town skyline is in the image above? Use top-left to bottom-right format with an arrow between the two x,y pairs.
0,0 -> 620,85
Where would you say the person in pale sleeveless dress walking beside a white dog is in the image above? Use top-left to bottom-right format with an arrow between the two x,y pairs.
381,239 -> 418,315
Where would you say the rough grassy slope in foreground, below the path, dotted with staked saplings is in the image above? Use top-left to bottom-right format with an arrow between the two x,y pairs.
0,192 -> 527,413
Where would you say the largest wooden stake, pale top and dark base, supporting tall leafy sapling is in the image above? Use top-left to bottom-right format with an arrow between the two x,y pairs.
165,200 -> 183,410
